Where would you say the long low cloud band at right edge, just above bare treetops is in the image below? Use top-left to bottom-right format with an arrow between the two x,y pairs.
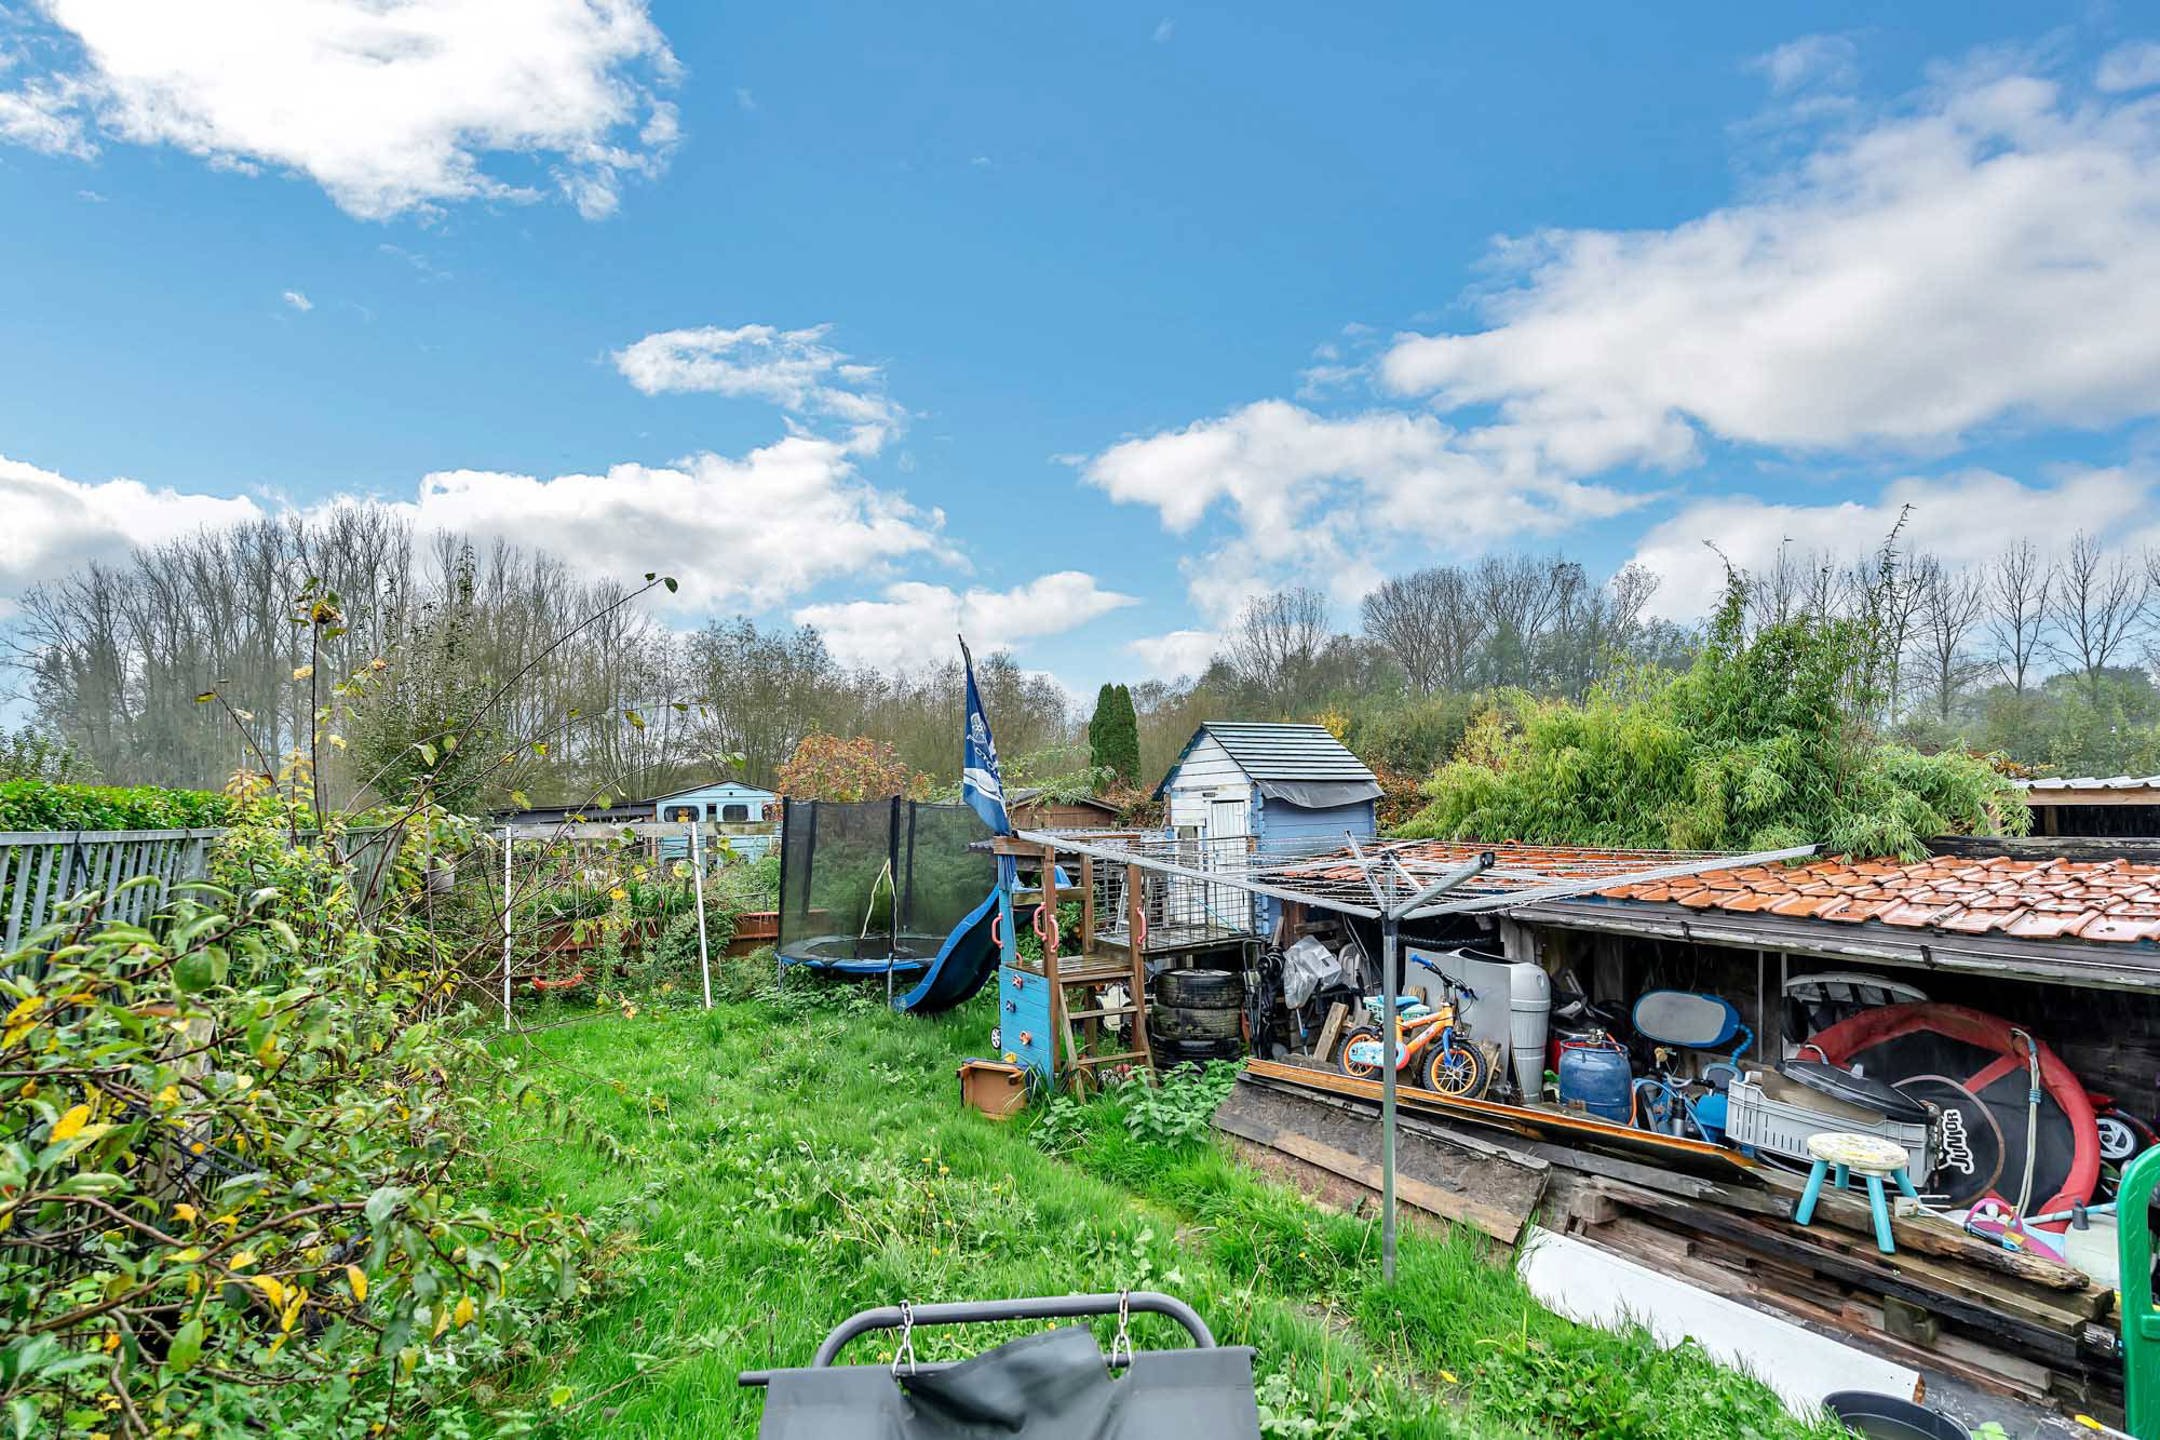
1635,468 -> 2154,620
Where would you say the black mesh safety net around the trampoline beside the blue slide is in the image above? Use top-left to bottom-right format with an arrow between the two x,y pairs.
780,799 -> 998,965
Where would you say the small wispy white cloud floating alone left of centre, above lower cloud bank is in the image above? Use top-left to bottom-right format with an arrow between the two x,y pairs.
616,326 -> 903,430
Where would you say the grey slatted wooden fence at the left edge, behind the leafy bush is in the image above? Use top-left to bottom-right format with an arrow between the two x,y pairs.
0,829 -> 225,954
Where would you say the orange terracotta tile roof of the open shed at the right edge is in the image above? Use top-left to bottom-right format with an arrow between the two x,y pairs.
1598,855 -> 2160,943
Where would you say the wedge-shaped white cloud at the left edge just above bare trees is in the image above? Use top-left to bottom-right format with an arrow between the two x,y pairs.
0,456 -> 264,617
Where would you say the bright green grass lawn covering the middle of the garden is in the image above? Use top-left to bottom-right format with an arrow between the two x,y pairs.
477,963 -> 1832,1440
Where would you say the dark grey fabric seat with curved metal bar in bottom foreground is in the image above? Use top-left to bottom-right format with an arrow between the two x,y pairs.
739,1291 -> 1259,1440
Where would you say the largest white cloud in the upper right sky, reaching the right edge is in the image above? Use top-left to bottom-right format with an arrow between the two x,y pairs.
1380,54 -> 2160,475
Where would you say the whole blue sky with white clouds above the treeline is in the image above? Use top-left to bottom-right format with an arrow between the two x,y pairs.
0,0 -> 2160,691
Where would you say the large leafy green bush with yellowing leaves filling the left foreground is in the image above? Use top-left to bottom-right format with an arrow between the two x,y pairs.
0,794 -> 585,1438
